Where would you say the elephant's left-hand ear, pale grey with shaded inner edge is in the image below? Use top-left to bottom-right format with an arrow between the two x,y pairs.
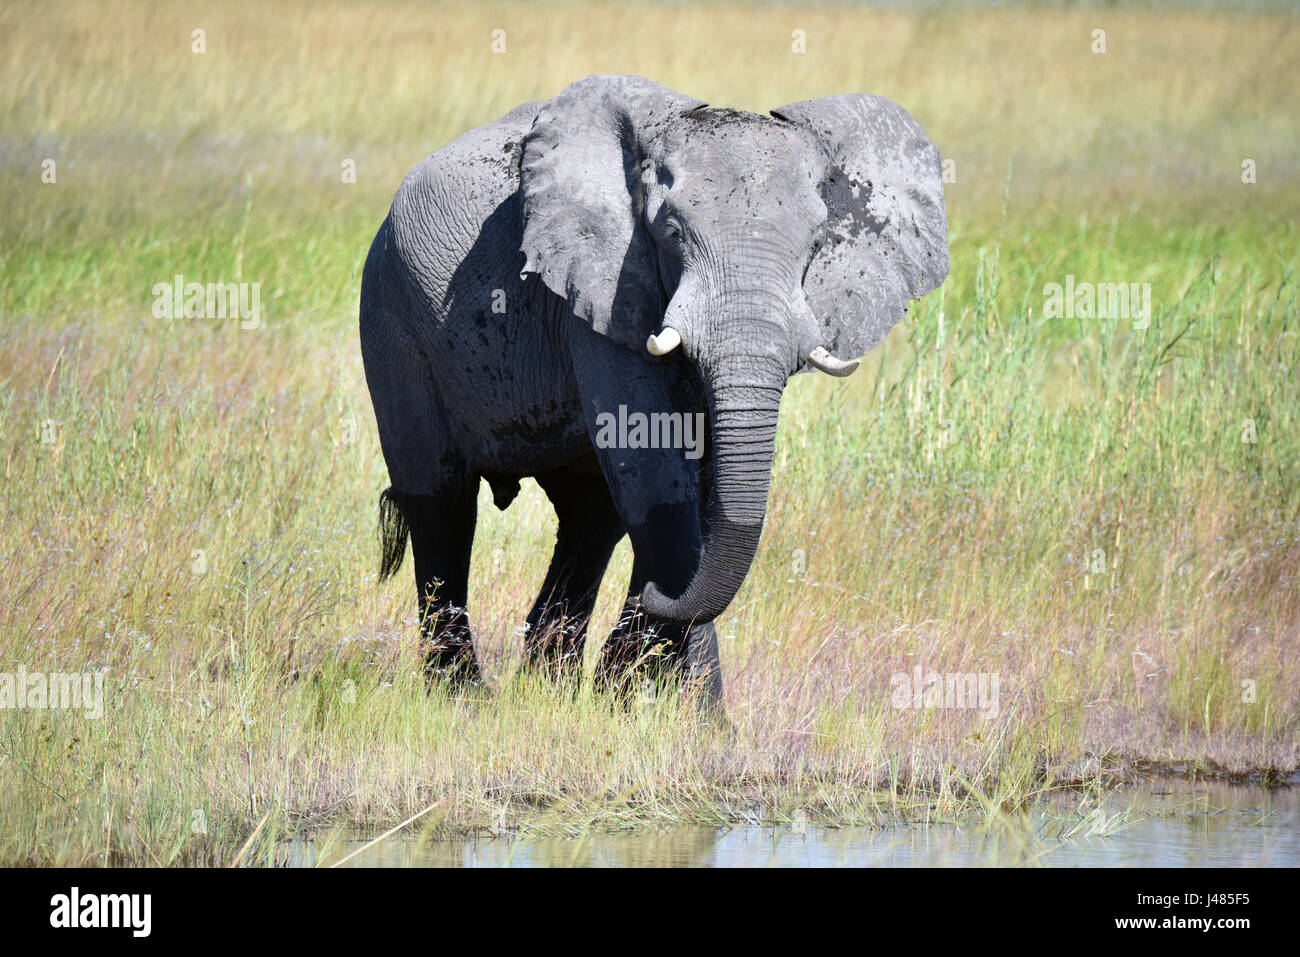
520,75 -> 705,350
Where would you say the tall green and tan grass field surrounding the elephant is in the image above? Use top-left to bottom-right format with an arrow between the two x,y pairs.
0,0 -> 1300,865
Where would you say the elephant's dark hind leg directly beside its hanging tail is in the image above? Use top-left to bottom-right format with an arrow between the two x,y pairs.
390,486 -> 482,685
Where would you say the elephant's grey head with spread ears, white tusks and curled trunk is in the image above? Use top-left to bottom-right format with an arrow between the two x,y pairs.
521,75 -> 948,623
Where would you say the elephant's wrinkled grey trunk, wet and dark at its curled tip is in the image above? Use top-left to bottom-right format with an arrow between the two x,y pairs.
641,358 -> 785,624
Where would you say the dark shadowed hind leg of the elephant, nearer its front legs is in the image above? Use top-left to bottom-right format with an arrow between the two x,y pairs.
525,471 -> 625,677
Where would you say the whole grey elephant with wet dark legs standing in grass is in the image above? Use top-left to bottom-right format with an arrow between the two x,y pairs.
361,75 -> 948,702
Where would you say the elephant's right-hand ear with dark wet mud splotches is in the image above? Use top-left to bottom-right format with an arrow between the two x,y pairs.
772,94 -> 948,359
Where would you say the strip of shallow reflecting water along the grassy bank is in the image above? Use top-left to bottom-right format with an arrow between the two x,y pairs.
287,780 -> 1300,867
